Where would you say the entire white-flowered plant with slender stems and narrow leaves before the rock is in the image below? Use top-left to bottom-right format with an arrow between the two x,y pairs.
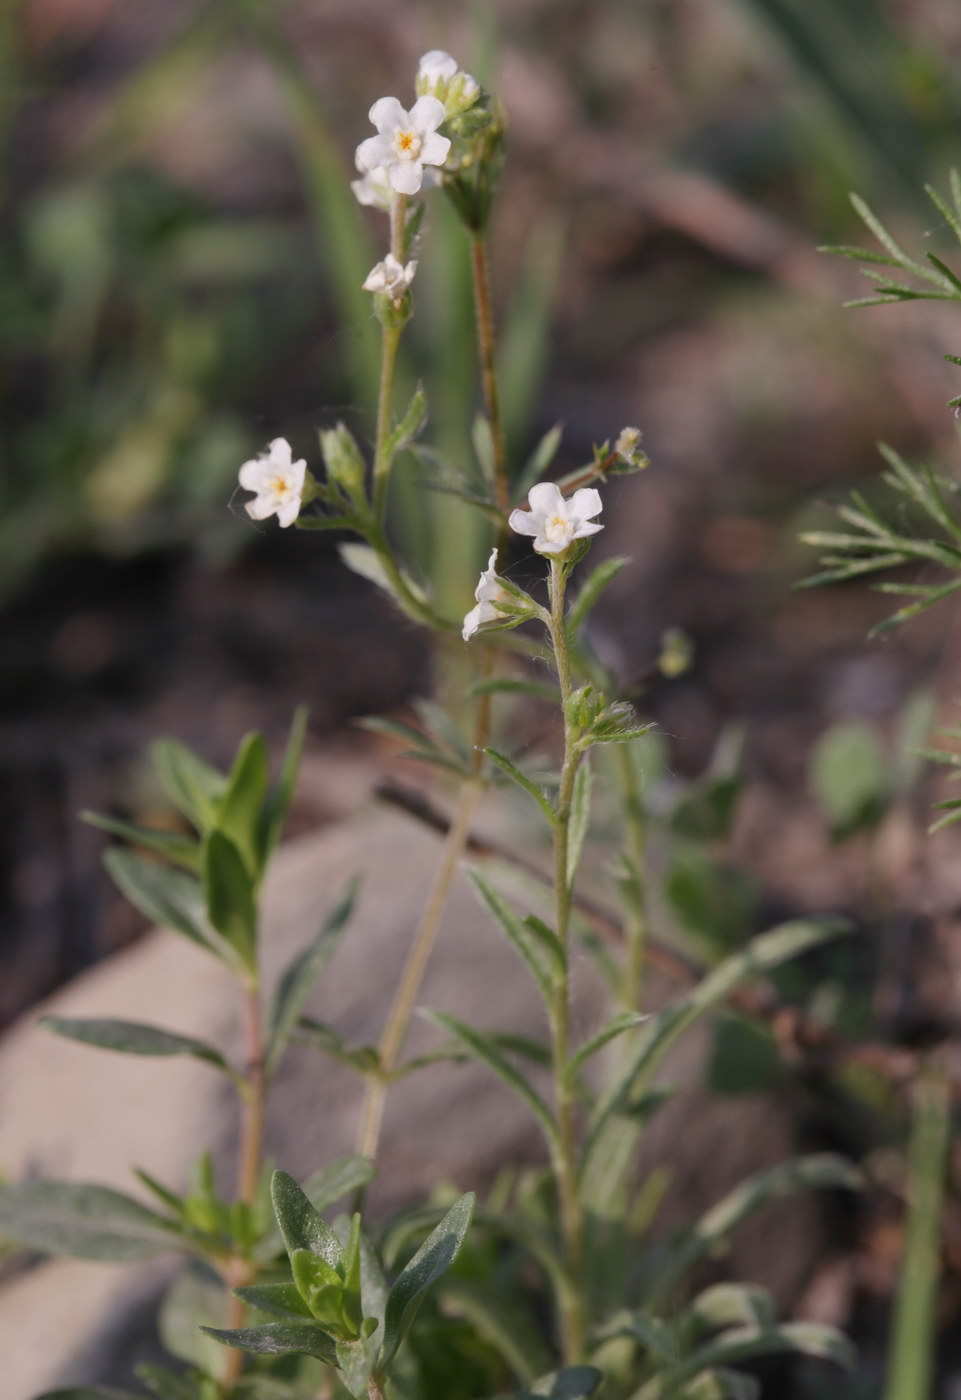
0,50 -> 855,1400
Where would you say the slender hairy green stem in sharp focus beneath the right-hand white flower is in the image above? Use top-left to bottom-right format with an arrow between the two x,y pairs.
549,559 -> 584,1365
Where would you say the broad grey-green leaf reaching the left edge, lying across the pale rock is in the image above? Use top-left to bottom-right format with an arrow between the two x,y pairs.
0,1182 -> 184,1263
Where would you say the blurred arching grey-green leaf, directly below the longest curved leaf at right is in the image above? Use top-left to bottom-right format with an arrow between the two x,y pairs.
647,1152 -> 862,1306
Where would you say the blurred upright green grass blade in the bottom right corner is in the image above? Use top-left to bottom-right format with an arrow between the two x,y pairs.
884,1067 -> 951,1400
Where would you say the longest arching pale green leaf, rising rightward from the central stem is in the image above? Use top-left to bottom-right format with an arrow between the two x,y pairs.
583,920 -> 846,1177
